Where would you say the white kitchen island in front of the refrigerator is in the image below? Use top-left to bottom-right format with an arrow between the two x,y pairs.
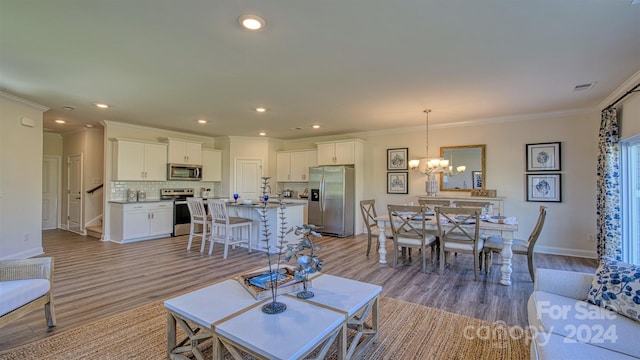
227,201 -> 304,253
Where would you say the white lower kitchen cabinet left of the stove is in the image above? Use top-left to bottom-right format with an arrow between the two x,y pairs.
110,201 -> 173,243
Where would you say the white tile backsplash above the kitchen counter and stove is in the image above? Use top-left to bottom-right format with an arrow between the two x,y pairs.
109,181 -> 220,201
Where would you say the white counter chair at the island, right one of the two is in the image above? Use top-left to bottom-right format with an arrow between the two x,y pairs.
207,199 -> 253,259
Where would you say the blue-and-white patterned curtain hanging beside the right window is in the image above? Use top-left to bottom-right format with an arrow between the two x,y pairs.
596,108 -> 622,262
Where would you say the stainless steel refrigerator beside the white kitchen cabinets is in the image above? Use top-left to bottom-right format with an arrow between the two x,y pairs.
308,166 -> 355,237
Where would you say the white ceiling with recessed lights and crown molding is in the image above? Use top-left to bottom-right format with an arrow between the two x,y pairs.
0,0 -> 640,139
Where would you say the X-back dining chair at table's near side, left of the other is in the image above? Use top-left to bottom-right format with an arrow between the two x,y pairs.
387,205 -> 437,273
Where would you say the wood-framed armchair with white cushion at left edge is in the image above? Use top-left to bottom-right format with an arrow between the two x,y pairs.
0,258 -> 56,327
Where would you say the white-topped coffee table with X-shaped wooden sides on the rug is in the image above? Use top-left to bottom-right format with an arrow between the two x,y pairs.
164,274 -> 382,359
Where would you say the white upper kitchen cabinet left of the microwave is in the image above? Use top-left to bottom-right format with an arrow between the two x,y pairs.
112,139 -> 167,181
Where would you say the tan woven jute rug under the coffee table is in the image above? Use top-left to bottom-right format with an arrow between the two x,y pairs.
0,297 -> 530,360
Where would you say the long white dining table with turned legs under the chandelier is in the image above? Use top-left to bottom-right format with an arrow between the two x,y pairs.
375,214 -> 518,286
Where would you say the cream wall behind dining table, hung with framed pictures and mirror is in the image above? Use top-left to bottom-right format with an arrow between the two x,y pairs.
358,110 -> 599,257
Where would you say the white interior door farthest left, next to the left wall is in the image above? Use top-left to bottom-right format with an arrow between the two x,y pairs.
42,156 -> 60,230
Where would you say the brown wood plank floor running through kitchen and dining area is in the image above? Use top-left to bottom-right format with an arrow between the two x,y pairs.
0,230 -> 596,350
